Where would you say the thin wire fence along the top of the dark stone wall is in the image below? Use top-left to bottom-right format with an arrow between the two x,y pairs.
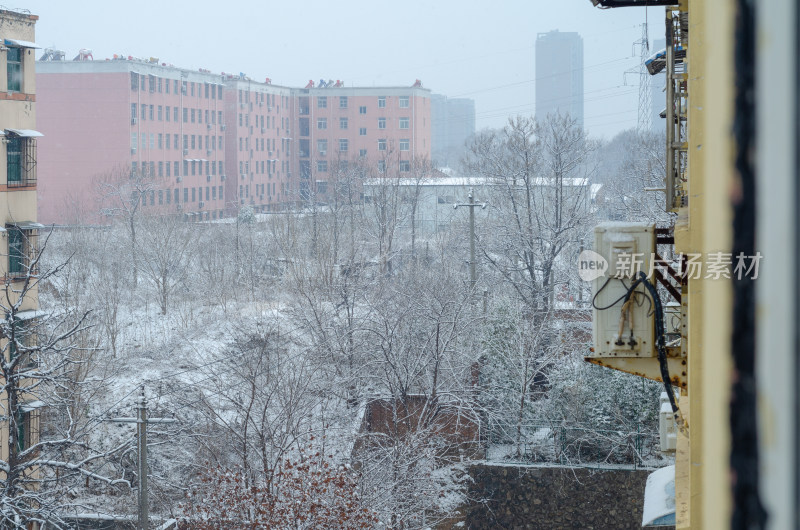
485,422 -> 665,469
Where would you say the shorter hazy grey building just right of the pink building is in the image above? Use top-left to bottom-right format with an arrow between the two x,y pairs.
431,94 -> 475,167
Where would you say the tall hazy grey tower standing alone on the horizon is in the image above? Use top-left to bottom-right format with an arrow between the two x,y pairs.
536,30 -> 583,128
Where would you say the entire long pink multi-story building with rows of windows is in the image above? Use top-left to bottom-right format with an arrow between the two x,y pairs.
37,53 -> 431,224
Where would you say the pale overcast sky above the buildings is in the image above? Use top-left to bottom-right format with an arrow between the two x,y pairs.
25,0 -> 664,138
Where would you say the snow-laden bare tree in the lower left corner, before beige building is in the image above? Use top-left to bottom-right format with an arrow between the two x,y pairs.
0,234 -> 129,529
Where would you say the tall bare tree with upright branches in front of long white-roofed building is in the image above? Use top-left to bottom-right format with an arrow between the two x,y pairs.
467,116 -> 596,314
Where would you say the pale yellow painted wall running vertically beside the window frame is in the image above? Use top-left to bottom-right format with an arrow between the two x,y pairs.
675,0 -> 734,529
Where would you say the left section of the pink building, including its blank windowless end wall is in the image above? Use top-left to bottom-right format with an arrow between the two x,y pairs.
36,58 -> 227,224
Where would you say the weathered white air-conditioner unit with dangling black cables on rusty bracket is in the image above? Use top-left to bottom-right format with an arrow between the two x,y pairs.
589,223 -> 657,357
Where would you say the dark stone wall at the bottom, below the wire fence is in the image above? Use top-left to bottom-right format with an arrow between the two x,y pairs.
465,465 -> 668,530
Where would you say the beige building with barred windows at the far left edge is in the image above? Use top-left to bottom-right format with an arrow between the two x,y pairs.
0,5 -> 41,486
